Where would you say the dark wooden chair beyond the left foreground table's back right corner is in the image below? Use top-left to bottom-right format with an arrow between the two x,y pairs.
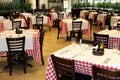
33,16 -> 43,31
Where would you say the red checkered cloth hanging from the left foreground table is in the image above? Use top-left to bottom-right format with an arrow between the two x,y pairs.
0,30 -> 42,63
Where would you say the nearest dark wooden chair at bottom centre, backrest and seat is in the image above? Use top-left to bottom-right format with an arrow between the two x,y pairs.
51,54 -> 91,80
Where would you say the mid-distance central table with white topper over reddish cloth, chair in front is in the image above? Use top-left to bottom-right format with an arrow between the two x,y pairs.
59,18 -> 91,39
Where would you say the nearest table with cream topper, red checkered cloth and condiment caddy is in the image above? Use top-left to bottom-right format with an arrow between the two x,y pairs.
46,44 -> 120,80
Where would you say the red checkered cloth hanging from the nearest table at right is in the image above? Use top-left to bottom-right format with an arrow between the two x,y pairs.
46,57 -> 120,80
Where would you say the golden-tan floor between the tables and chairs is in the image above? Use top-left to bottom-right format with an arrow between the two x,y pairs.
0,26 -> 100,80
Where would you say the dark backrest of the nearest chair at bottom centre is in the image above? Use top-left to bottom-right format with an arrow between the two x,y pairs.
51,54 -> 75,80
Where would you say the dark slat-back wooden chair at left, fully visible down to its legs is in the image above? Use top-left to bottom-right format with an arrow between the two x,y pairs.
6,37 -> 27,75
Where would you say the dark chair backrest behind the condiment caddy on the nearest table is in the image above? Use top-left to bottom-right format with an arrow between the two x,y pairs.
93,33 -> 109,48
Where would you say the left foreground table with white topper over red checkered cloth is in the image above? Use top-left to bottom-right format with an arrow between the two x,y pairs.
0,29 -> 42,64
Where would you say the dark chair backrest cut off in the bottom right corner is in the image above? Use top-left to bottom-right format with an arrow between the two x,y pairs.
92,65 -> 120,80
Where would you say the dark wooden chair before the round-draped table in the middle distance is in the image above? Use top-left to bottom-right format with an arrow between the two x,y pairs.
70,21 -> 82,41
